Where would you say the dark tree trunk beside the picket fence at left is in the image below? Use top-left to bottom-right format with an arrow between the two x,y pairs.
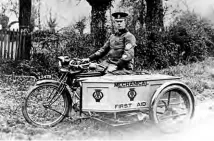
19,0 -> 32,59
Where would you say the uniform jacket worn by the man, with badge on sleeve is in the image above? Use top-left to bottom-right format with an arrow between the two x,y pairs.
89,29 -> 136,69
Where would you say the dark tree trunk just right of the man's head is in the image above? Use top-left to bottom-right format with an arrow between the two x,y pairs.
145,0 -> 164,32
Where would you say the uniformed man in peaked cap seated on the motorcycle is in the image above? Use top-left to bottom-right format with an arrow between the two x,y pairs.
85,12 -> 136,74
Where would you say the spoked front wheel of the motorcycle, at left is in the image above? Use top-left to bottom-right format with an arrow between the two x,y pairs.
22,83 -> 69,128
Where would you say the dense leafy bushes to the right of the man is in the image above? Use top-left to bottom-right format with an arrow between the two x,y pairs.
136,11 -> 214,69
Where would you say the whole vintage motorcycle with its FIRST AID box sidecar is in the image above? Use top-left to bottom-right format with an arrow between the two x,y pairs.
22,56 -> 195,132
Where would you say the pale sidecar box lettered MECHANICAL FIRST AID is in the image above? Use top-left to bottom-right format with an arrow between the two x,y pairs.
82,74 -> 180,112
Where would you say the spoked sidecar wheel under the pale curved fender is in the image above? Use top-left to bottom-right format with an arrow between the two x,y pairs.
150,85 -> 194,133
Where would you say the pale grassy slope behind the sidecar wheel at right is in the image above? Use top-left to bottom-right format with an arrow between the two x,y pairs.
153,58 -> 214,96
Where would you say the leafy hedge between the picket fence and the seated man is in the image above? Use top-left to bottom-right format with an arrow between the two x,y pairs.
3,29 -> 95,75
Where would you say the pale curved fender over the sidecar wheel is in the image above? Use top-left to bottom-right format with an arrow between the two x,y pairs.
150,81 -> 195,113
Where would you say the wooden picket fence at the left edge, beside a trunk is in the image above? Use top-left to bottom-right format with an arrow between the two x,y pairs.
0,30 -> 26,60
